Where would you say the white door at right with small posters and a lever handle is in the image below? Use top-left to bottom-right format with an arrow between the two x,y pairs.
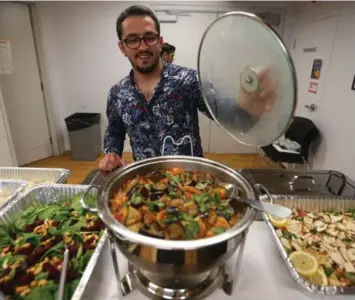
291,17 -> 337,119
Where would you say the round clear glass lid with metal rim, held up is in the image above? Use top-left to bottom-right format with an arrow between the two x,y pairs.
198,12 -> 297,147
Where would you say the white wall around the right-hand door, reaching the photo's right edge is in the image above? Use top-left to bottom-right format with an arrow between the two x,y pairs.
286,2 -> 355,178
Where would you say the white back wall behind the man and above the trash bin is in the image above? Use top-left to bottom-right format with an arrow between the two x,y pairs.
32,1 -> 285,152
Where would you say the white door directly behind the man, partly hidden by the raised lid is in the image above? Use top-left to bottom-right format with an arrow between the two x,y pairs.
161,13 -> 217,152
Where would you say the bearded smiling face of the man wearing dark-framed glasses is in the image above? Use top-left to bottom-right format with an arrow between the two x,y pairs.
119,16 -> 163,73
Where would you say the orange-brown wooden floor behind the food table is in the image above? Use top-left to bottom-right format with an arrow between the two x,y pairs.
28,153 -> 281,184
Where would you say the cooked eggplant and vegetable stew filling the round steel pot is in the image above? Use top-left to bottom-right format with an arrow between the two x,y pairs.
110,168 -> 242,240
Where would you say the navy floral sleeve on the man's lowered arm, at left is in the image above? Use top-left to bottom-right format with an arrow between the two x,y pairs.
104,89 -> 126,156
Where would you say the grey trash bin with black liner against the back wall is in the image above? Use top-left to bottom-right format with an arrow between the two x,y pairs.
65,113 -> 101,160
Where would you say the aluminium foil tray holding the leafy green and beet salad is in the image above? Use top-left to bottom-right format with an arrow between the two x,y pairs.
0,184 -> 108,300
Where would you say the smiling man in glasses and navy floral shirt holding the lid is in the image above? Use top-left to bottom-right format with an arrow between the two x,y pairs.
100,5 -> 271,171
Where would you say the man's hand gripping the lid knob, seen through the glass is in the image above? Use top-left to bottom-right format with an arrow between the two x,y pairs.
237,68 -> 277,117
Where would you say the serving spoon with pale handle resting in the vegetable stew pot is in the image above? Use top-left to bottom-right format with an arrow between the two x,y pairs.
219,183 -> 292,219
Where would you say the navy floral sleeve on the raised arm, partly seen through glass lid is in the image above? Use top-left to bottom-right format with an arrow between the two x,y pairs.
193,71 -> 259,133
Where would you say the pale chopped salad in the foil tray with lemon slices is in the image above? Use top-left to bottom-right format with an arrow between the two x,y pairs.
271,209 -> 355,287
